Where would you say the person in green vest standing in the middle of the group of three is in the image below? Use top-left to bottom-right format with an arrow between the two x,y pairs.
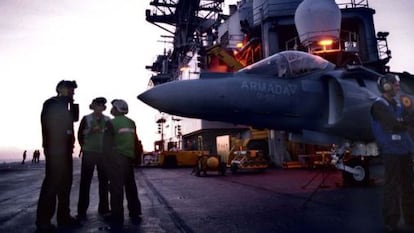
77,97 -> 110,219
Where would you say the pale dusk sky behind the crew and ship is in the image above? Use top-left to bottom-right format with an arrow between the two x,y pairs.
0,0 -> 414,162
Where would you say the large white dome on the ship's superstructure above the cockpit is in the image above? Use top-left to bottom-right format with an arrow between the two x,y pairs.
295,0 -> 341,45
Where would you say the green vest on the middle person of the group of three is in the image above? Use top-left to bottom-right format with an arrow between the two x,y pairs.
82,113 -> 110,152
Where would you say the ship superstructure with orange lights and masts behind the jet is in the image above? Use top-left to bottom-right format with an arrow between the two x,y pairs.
147,0 -> 398,164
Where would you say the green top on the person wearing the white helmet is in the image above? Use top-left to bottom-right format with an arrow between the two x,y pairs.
111,115 -> 136,158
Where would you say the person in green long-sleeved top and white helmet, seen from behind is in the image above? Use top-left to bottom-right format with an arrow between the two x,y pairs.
104,99 -> 141,227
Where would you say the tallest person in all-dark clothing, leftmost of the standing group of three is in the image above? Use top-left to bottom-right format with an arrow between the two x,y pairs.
36,80 -> 79,232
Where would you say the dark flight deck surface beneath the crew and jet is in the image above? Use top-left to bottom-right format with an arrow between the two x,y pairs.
0,159 -> 412,233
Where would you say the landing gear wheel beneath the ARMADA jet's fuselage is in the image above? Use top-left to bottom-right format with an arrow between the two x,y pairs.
342,158 -> 369,185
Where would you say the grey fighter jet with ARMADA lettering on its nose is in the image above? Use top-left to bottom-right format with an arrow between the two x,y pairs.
138,51 -> 414,185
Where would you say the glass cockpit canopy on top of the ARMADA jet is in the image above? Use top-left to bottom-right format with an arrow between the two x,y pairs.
238,50 -> 335,78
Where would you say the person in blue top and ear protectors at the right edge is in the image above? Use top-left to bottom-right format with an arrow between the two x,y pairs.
371,74 -> 414,232
